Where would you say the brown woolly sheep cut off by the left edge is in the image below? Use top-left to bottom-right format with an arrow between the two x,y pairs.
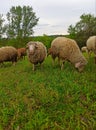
0,46 -> 18,65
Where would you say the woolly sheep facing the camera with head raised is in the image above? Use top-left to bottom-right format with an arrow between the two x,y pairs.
26,41 -> 47,71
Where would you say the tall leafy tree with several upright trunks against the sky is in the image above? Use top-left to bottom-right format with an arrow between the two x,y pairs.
7,6 -> 39,38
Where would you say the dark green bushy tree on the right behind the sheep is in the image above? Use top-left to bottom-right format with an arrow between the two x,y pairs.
68,14 -> 96,46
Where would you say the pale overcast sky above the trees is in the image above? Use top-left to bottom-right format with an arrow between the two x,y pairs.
0,0 -> 96,36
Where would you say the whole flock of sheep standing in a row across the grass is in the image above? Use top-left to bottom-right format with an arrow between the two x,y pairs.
0,36 -> 96,72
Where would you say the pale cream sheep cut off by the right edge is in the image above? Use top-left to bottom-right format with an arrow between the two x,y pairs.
86,36 -> 96,64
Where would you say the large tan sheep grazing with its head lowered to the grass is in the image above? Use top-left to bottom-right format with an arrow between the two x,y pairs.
48,37 -> 87,72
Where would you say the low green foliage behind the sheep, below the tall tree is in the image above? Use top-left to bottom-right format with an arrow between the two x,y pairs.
0,35 -> 56,48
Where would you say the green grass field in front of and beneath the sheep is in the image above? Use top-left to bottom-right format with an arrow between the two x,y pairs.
0,56 -> 96,130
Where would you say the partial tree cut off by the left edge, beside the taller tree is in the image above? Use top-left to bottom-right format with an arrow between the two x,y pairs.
0,14 -> 6,39
